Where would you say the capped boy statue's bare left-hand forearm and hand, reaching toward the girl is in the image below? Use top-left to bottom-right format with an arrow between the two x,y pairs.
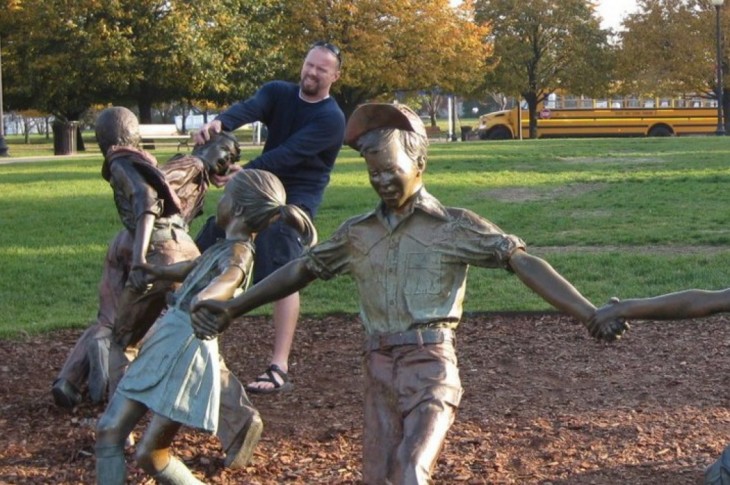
191,258 -> 316,339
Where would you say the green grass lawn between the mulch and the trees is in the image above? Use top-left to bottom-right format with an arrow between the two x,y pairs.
0,137 -> 730,337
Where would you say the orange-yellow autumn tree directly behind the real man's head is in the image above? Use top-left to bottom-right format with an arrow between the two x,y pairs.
270,0 -> 491,119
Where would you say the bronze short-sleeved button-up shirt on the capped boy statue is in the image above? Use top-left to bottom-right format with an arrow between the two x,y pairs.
306,188 -> 525,335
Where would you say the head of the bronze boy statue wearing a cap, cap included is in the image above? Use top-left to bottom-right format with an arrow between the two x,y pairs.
345,103 -> 428,210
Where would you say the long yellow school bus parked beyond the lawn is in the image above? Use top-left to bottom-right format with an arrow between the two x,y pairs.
477,94 -> 717,140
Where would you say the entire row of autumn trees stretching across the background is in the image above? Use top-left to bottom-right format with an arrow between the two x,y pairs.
0,0 -> 730,141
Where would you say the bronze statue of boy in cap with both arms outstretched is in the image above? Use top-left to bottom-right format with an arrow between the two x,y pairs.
192,104 -> 624,484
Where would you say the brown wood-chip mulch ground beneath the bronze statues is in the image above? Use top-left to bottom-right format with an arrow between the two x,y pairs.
0,314 -> 730,485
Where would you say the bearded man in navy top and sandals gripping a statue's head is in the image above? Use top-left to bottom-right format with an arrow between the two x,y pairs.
195,41 -> 345,394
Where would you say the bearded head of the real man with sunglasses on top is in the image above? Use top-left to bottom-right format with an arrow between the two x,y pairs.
299,41 -> 342,102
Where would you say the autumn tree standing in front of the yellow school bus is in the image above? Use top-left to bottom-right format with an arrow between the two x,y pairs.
476,0 -> 614,138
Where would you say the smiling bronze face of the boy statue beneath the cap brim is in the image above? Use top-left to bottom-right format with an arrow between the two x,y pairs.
363,140 -> 423,210
